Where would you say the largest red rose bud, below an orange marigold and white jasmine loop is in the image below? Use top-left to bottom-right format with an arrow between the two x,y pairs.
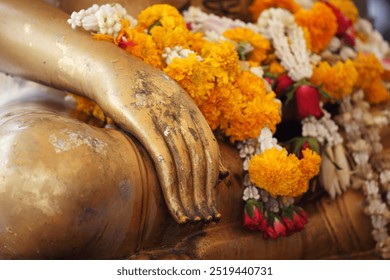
295,85 -> 324,120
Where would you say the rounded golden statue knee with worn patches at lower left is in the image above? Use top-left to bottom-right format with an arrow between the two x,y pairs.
0,112 -> 151,259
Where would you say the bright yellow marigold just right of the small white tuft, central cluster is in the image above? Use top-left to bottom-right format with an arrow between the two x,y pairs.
200,42 -> 240,87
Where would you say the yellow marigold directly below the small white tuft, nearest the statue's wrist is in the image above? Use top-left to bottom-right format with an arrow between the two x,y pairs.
164,54 -> 215,106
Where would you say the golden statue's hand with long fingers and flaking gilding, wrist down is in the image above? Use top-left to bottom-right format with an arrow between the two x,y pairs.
96,57 -> 220,223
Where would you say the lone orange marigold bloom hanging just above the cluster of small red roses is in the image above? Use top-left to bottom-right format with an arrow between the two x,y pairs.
248,148 -> 321,197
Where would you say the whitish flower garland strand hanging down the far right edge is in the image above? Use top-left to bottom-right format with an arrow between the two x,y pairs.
337,90 -> 390,259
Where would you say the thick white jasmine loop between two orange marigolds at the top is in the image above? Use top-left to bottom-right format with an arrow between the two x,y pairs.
257,8 -> 313,81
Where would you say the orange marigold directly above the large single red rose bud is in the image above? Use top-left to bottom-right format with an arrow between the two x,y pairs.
310,60 -> 358,99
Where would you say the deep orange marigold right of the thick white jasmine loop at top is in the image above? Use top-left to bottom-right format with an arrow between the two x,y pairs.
295,2 -> 337,53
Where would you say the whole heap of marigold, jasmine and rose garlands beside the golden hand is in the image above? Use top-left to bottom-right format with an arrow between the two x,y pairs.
69,0 -> 390,249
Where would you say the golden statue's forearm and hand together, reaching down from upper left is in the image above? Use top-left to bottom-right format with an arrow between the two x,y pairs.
0,0 -> 220,223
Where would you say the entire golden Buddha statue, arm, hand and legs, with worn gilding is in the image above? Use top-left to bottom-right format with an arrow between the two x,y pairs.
0,0 -> 375,259
